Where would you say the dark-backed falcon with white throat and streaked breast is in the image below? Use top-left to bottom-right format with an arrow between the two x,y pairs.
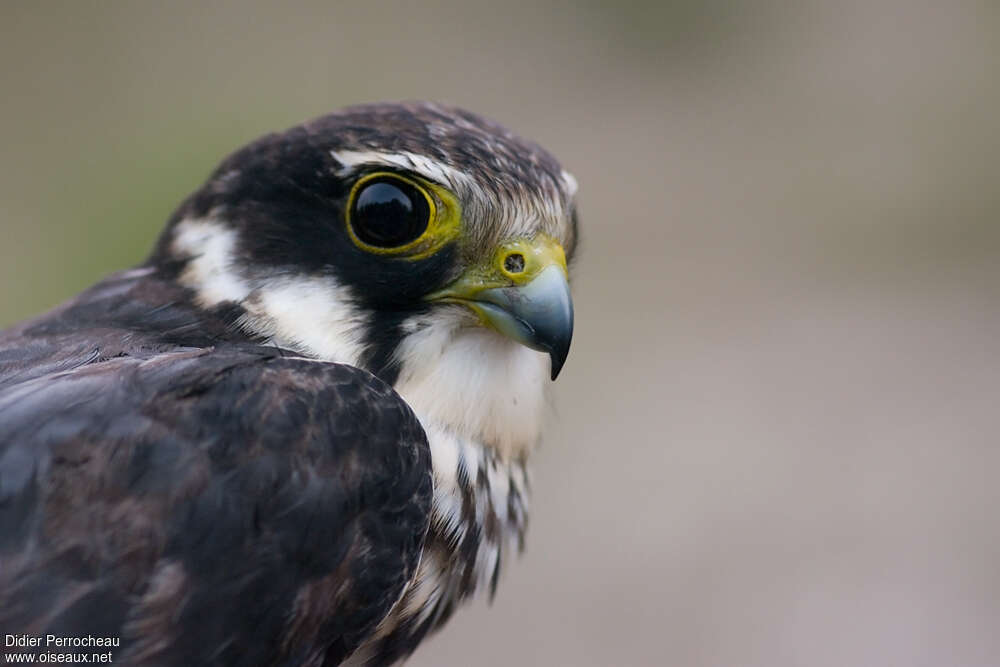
0,103 -> 577,666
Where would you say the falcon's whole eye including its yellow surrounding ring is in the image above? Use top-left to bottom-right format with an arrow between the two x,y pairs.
344,171 -> 461,259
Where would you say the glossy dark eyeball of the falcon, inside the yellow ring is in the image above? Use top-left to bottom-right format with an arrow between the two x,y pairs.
351,179 -> 430,248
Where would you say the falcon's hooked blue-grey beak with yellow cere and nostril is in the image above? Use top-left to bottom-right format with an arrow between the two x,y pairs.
428,235 -> 573,380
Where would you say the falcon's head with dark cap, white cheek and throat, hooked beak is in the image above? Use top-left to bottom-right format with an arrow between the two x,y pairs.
155,104 -> 577,454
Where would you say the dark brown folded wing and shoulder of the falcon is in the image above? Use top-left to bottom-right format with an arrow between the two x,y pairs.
0,308 -> 431,664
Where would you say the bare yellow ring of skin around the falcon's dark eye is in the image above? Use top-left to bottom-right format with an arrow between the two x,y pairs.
344,171 -> 462,260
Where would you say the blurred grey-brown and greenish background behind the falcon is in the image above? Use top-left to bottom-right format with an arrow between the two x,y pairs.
0,0 -> 1000,667
